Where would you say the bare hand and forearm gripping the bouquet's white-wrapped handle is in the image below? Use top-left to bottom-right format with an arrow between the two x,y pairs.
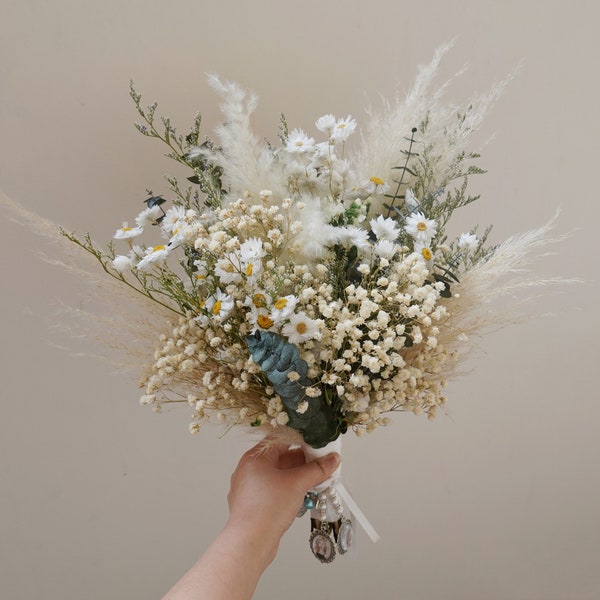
163,442 -> 340,600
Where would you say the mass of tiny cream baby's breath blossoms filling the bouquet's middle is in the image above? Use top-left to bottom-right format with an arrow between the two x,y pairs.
115,182 -> 474,432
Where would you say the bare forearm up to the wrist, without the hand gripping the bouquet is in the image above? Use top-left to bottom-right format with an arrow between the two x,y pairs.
163,521 -> 279,600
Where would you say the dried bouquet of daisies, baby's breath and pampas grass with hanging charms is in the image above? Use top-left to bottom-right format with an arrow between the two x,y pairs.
58,44 -> 560,562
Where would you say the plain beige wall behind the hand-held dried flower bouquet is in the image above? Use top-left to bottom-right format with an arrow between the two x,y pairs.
0,0 -> 600,600
